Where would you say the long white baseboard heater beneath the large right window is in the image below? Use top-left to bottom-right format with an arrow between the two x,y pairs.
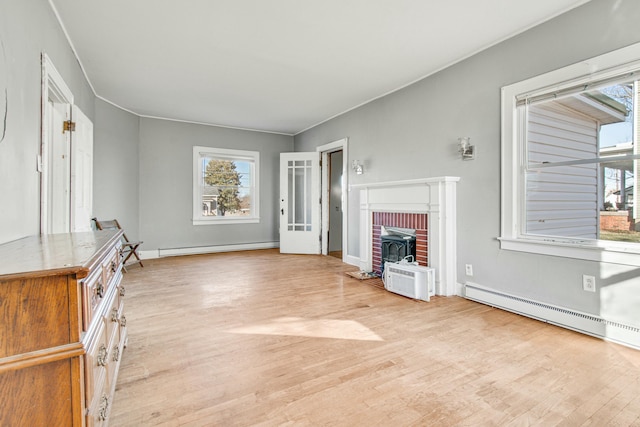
464,283 -> 640,349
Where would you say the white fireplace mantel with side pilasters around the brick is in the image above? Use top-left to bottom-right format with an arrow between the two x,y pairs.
349,176 -> 460,296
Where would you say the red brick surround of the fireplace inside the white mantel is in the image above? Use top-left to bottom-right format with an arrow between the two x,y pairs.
371,212 -> 429,274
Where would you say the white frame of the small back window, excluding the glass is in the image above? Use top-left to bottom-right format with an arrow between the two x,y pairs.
192,146 -> 260,225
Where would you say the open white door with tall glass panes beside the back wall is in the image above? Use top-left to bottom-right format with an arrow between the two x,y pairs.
279,152 -> 320,254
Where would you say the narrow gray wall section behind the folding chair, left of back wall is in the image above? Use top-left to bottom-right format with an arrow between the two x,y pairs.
93,98 -> 140,240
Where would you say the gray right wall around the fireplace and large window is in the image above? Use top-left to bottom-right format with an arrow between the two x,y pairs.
295,0 -> 640,326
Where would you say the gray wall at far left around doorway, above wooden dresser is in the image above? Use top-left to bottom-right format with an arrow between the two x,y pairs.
0,0 -> 94,242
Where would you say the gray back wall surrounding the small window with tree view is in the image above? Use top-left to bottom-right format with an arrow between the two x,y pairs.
139,118 -> 293,250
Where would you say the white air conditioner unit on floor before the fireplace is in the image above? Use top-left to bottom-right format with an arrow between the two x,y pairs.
384,262 -> 436,301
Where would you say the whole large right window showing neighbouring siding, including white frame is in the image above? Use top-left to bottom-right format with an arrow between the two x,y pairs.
500,44 -> 640,266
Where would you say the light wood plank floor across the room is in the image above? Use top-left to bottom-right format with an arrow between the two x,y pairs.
110,250 -> 640,427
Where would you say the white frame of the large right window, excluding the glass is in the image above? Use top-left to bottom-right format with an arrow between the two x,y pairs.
498,43 -> 640,267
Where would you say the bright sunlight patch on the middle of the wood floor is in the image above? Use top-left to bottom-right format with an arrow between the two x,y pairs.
227,317 -> 383,341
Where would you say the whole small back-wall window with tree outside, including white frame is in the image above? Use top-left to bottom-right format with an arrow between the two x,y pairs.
193,146 -> 260,225
